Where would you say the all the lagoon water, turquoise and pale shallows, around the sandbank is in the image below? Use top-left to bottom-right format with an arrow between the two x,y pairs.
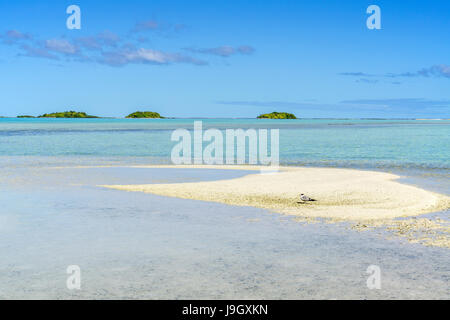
0,119 -> 450,299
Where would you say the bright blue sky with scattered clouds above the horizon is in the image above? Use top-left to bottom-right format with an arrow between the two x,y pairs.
0,0 -> 450,118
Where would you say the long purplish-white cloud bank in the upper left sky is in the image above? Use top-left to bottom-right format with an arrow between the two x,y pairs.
0,20 -> 255,67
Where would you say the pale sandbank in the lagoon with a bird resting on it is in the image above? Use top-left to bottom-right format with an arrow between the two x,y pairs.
104,166 -> 450,220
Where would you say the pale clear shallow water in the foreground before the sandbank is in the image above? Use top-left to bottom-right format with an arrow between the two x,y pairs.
0,164 -> 450,299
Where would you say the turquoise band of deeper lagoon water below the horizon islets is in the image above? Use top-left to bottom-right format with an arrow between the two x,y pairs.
0,119 -> 450,170
